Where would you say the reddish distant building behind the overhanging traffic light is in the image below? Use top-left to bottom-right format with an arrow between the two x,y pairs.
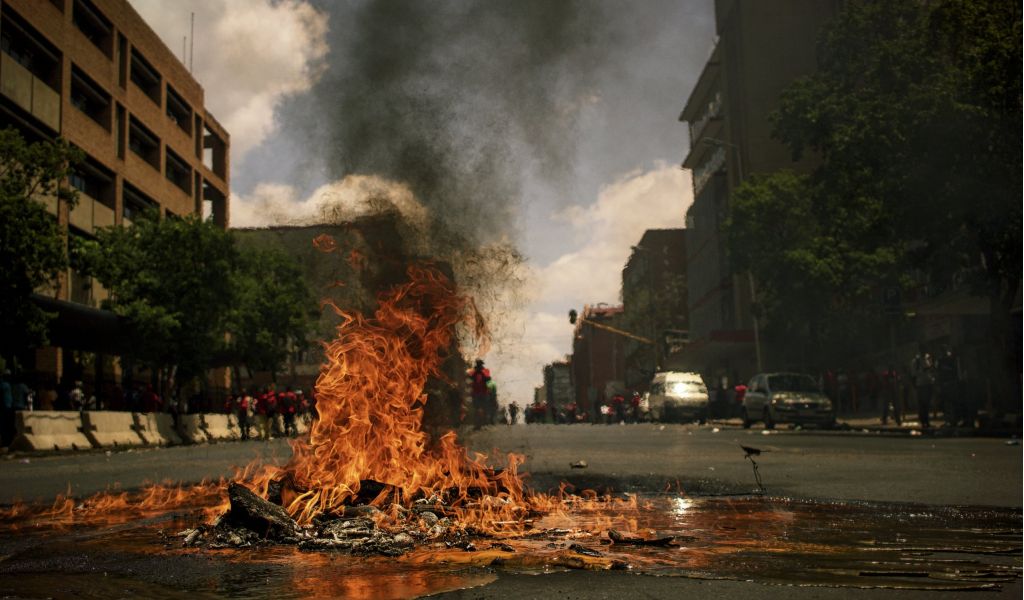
572,304 -> 626,420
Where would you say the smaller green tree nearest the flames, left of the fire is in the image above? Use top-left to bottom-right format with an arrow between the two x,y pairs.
228,243 -> 317,377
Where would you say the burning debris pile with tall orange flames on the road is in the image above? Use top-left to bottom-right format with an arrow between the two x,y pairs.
176,266 -> 543,555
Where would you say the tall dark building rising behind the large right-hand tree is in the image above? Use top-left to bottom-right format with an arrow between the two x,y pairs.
679,0 -> 842,382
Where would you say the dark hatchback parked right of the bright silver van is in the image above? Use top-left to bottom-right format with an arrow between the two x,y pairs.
742,373 -> 836,429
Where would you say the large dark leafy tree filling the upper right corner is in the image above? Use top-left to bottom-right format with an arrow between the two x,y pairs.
729,0 -> 1022,382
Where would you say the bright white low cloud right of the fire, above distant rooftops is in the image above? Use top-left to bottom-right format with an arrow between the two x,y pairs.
488,164 -> 692,404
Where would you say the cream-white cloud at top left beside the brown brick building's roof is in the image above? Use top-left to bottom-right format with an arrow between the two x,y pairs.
130,0 -> 328,163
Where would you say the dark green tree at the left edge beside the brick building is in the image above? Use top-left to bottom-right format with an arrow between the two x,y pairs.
0,128 -> 81,358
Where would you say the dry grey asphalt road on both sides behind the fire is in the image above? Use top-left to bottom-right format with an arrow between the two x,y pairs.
0,424 -> 1024,507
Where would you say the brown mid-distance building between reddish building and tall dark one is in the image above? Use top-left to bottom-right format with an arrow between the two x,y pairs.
623,229 -> 689,392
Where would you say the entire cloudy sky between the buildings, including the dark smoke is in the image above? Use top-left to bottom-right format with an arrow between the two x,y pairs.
130,0 -> 714,404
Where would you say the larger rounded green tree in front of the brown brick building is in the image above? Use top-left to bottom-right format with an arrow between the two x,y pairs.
88,212 -> 239,393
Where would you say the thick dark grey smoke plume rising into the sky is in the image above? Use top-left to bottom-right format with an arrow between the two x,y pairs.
285,0 -> 611,250
